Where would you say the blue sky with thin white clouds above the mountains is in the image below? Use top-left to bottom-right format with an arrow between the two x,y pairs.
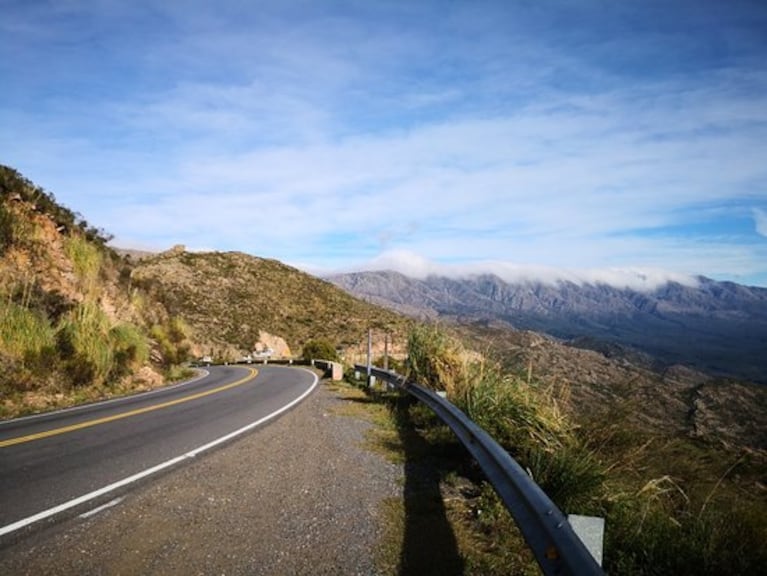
0,0 -> 767,286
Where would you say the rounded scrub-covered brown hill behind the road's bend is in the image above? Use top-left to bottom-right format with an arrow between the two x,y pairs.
131,247 -> 410,358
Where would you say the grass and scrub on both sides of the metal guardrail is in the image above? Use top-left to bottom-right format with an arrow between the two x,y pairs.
360,326 -> 767,575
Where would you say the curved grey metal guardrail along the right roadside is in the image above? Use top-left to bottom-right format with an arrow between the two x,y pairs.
355,365 -> 604,576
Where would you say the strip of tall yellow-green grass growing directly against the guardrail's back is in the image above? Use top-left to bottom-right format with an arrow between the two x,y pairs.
408,326 -> 604,513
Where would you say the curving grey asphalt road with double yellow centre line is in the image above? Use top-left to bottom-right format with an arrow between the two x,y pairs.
0,365 -> 317,537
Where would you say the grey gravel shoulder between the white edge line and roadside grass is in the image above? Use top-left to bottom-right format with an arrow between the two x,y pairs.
0,383 -> 403,576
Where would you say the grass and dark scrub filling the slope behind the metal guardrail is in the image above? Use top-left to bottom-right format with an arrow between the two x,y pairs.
392,327 -> 767,575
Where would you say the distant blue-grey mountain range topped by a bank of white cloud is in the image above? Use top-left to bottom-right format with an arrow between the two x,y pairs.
328,271 -> 767,384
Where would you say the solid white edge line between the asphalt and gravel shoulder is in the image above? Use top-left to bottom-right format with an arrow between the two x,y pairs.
0,368 -> 319,536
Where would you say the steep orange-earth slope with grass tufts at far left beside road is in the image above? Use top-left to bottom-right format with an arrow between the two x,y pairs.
0,166 -> 178,417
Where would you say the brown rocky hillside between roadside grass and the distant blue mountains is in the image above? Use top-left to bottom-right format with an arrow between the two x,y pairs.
455,323 -> 767,454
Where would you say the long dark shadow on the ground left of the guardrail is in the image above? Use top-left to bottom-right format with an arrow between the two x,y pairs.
392,397 -> 464,576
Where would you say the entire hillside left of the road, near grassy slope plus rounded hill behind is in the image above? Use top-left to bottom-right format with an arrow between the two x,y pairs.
0,166 -> 411,417
